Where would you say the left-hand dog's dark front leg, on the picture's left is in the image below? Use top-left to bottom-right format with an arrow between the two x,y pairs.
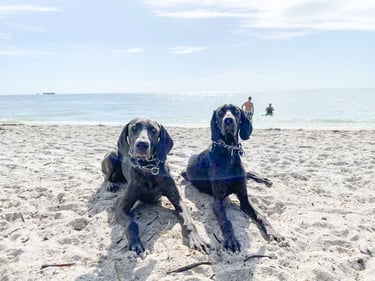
116,184 -> 145,255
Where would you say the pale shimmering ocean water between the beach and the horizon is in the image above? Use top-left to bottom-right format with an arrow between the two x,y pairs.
0,89 -> 375,129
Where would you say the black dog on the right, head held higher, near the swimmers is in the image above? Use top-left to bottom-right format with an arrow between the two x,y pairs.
183,104 -> 280,252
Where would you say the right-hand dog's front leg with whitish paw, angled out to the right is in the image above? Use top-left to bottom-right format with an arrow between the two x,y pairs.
237,184 -> 282,241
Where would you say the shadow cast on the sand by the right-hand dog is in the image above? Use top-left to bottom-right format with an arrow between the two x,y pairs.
180,179 -> 266,281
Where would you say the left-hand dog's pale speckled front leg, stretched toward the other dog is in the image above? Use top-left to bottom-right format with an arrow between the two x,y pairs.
164,179 -> 209,254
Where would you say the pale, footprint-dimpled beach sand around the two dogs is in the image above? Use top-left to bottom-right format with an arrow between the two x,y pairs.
0,124 -> 375,281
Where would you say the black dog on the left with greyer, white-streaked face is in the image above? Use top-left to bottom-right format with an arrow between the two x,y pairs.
102,118 -> 208,255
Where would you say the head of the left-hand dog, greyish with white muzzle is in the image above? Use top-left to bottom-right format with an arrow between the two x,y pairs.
117,118 -> 173,161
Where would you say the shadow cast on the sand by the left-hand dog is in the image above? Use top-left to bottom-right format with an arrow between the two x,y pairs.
76,183 -> 178,281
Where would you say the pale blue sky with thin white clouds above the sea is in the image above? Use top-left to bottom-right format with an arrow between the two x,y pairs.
0,0 -> 375,94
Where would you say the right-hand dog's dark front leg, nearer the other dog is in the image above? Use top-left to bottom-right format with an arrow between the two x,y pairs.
213,198 -> 241,252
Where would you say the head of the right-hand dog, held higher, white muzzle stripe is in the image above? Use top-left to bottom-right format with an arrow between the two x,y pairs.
211,104 -> 253,144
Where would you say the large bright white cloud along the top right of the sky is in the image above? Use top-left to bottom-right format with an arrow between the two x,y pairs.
145,0 -> 375,39
